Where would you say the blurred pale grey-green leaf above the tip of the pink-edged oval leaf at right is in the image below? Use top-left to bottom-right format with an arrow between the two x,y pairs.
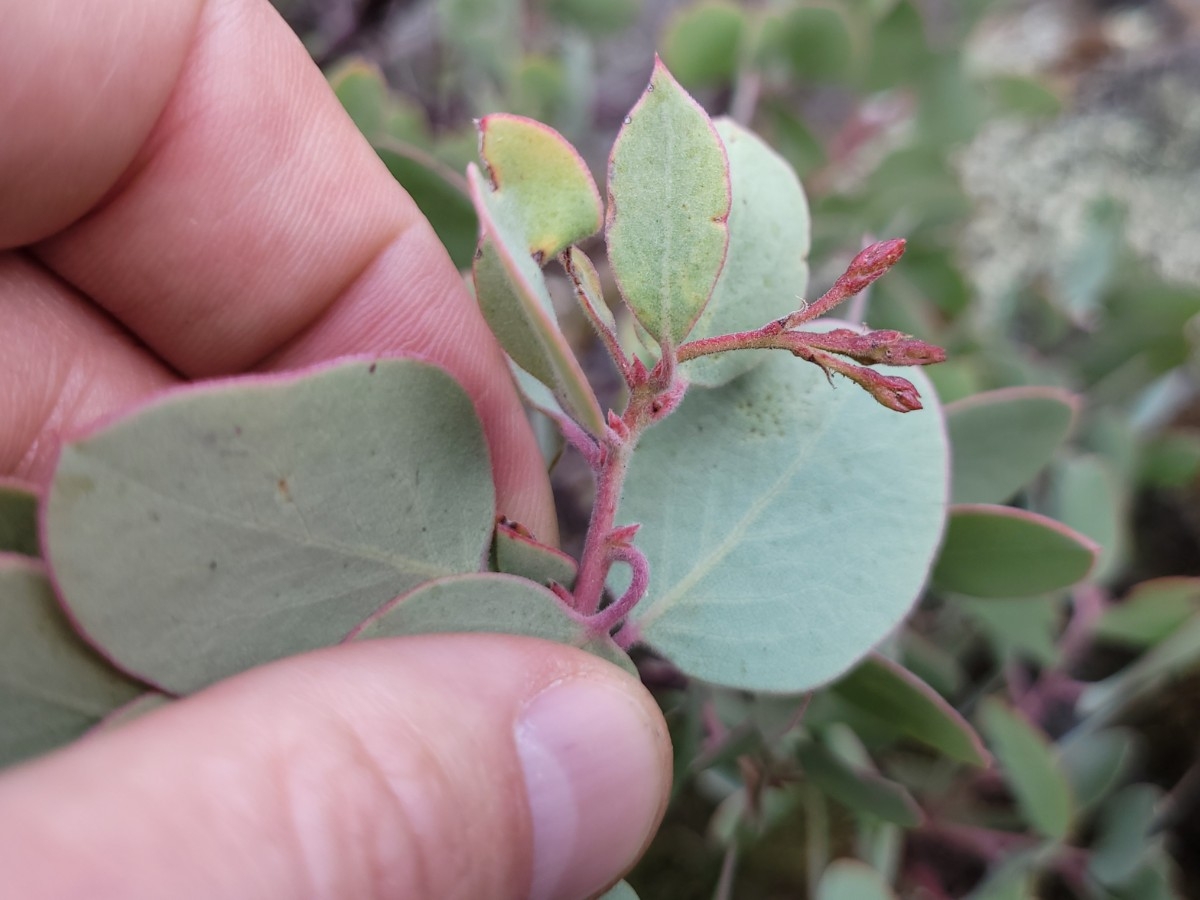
1052,455 -> 1128,582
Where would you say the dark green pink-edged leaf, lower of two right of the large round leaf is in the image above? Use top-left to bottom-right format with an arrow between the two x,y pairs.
932,504 -> 1099,598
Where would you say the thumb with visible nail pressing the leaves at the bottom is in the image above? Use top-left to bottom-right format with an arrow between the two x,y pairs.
0,635 -> 671,900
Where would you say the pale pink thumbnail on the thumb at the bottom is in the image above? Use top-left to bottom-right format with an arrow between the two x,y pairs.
516,678 -> 671,900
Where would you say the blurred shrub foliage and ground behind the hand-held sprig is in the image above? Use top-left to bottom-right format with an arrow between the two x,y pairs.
276,0 -> 1200,900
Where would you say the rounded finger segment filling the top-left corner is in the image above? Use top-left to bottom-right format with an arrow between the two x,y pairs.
0,0 -> 203,248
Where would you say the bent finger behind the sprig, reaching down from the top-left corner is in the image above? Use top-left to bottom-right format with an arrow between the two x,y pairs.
0,0 -> 557,541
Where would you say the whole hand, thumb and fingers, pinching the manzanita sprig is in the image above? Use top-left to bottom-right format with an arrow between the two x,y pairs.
0,0 -> 670,900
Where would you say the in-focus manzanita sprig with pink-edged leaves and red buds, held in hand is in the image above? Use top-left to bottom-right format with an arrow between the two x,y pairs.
0,62 -> 955,897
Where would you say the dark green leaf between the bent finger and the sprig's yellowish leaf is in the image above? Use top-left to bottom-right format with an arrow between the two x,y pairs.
376,138 -> 479,269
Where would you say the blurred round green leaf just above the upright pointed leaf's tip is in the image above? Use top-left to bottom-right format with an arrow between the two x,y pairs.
661,0 -> 746,88
